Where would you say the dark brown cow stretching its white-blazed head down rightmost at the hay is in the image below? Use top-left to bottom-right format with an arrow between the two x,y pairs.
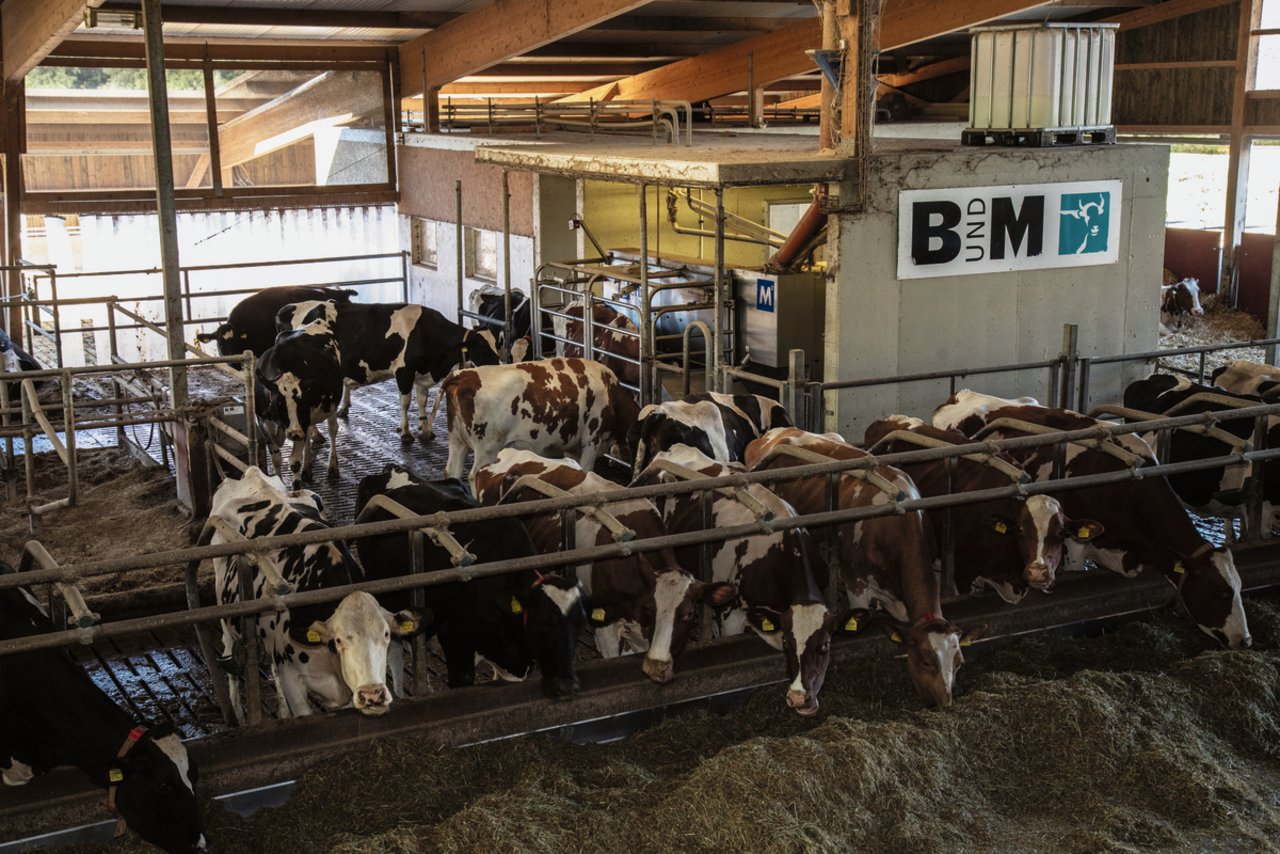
962,406 -> 1252,649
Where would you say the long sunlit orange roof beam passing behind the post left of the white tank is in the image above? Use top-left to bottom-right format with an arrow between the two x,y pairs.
563,0 -> 1049,101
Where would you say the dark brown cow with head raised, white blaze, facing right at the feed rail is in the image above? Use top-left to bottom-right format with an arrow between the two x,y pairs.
863,415 -> 1101,604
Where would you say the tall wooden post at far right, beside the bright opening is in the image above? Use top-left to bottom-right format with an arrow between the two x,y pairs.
1219,0 -> 1262,306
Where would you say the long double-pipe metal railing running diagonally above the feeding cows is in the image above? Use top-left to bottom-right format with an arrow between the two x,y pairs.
0,396 -> 1280,686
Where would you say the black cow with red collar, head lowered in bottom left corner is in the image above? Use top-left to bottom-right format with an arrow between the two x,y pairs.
0,561 -> 206,854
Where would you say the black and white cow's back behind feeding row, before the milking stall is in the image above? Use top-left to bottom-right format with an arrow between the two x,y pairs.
627,392 -> 791,478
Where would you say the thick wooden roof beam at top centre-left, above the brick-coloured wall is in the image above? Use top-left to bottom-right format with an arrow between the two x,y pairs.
399,0 -> 646,95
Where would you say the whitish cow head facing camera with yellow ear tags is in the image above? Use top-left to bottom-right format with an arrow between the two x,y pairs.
307,593 -> 422,714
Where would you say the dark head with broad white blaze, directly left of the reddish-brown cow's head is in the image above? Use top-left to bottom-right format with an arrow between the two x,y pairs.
748,602 -> 856,716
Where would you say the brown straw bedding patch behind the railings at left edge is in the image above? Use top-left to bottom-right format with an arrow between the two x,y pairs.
0,449 -> 191,594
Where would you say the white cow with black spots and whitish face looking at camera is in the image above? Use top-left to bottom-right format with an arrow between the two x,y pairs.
210,466 -> 421,717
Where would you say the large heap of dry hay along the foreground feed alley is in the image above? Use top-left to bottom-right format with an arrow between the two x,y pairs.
72,598 -> 1280,854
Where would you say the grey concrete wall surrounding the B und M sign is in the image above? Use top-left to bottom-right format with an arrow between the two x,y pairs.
824,143 -> 1169,440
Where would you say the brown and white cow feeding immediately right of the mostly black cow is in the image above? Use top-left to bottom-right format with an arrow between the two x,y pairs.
475,448 -> 737,682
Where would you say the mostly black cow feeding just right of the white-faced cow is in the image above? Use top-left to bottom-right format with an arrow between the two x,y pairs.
356,463 -> 589,698
